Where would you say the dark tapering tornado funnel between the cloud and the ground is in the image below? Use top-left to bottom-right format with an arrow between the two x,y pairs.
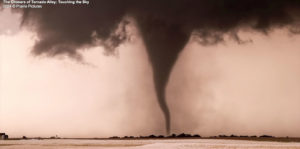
138,19 -> 190,134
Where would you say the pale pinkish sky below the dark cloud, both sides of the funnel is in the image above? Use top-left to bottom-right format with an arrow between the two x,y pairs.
0,10 -> 300,137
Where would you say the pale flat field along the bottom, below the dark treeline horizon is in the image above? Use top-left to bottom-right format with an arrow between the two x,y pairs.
0,139 -> 300,149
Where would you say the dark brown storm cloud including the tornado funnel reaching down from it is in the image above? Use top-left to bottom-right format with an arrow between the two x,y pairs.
3,0 -> 300,134
